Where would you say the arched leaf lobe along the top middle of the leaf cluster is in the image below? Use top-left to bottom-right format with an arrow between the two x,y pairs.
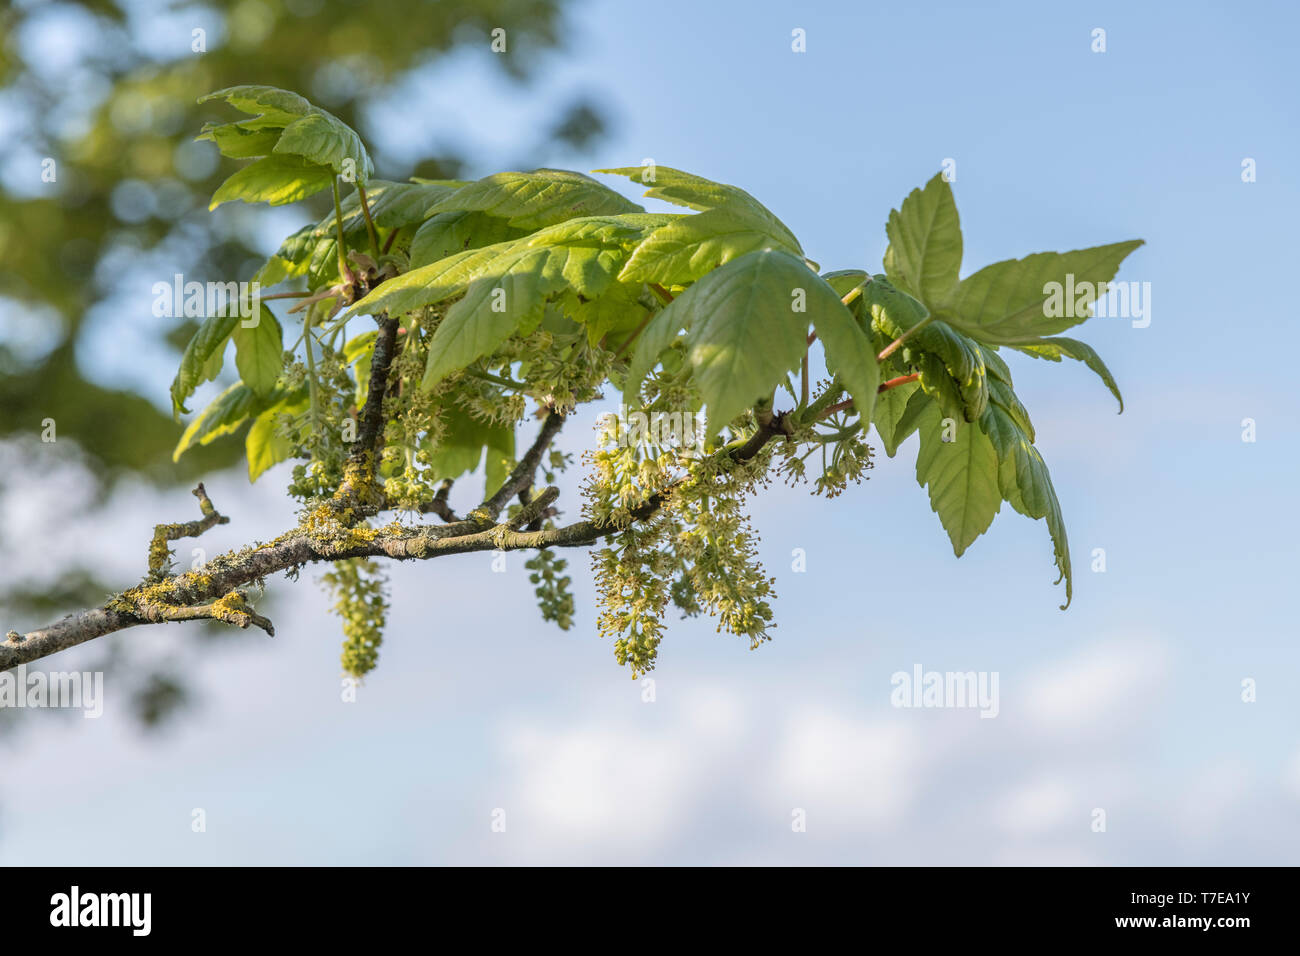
434,169 -> 645,230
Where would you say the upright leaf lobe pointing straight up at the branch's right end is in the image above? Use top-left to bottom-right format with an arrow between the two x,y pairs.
885,173 -> 962,308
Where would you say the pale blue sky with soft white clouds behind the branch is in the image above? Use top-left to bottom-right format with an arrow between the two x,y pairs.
0,3 -> 1300,864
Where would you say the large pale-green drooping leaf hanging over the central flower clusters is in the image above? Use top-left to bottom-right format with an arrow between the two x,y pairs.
655,250 -> 826,434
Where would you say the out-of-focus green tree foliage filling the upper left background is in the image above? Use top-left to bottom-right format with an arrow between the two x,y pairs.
0,0 -> 602,483
